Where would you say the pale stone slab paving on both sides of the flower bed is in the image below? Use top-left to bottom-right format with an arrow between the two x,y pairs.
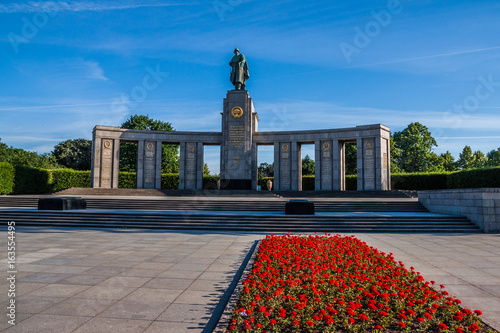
0,228 -> 500,333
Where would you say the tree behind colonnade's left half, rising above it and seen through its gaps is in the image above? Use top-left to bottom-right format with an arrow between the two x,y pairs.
120,114 -> 179,173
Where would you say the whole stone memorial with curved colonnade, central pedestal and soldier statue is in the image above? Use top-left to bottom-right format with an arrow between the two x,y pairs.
91,49 -> 391,191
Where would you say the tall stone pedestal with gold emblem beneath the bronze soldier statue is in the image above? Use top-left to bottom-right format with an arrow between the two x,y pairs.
220,90 -> 259,190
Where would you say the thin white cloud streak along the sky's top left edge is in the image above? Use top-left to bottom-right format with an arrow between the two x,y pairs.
0,1 -> 190,14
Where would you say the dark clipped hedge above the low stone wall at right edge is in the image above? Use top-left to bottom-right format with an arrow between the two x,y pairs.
446,167 -> 500,189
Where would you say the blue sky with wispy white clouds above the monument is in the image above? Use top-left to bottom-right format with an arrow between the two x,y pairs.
0,0 -> 500,171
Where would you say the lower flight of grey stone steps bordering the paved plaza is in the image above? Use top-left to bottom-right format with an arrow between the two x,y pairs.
0,210 -> 479,233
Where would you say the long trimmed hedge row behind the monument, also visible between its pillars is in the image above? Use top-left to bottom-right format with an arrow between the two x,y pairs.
4,162 -> 500,194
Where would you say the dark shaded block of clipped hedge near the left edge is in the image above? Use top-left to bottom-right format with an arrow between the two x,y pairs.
14,165 -> 52,194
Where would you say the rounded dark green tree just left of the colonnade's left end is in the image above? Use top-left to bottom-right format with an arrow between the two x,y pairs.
52,139 -> 92,170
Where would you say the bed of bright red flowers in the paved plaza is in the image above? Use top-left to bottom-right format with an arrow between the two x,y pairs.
229,235 -> 492,332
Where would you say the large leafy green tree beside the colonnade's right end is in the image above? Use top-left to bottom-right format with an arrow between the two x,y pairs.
393,122 -> 439,172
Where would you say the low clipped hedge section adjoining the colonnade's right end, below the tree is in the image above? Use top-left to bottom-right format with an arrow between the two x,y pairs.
391,172 -> 448,190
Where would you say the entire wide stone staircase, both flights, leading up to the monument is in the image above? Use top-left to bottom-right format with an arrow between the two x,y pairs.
0,192 -> 480,233
